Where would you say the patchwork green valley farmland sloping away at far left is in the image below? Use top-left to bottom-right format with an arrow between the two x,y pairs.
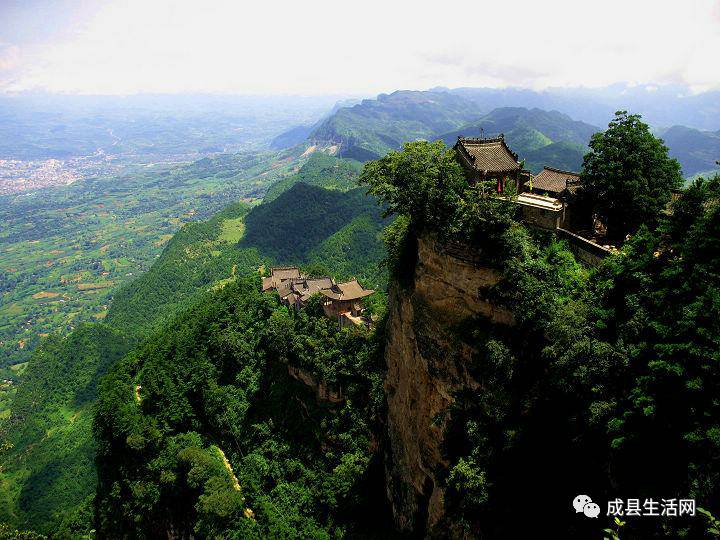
0,151 -> 306,368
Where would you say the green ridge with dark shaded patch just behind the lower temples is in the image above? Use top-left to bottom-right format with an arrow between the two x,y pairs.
106,181 -> 384,335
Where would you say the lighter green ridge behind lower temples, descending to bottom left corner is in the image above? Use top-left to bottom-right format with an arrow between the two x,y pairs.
0,152 -> 387,533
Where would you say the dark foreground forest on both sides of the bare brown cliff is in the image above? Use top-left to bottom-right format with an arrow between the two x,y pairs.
90,127 -> 720,538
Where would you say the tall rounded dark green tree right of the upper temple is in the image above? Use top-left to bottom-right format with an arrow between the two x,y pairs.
582,111 -> 683,239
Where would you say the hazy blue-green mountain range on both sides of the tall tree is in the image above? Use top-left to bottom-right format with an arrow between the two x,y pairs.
307,89 -> 720,176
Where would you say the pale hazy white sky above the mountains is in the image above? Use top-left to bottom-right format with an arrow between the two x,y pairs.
0,0 -> 720,95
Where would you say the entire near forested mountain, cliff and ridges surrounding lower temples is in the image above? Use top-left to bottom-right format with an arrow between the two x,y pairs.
0,92 -> 720,540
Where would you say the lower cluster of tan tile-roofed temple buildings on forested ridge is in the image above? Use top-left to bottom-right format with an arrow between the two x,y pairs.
262,266 -> 375,327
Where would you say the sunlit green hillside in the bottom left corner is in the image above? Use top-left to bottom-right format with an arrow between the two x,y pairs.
0,324 -> 129,533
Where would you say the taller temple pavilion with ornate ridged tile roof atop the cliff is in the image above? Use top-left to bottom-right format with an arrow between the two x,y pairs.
454,133 -> 530,193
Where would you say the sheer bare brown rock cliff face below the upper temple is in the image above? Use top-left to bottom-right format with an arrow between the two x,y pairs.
385,233 -> 514,536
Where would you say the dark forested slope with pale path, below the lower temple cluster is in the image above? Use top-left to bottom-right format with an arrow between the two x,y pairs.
95,277 -> 385,540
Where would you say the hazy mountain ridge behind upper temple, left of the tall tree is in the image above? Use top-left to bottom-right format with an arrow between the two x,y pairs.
312,96 -> 600,172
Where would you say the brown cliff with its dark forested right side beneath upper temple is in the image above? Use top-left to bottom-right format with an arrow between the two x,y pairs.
362,141 -> 720,540
